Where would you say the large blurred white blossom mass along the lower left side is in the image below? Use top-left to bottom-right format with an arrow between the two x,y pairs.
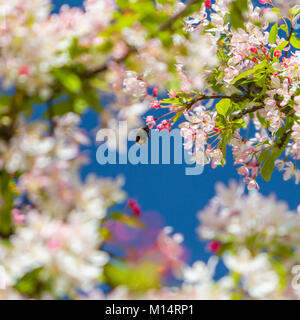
0,113 -> 125,298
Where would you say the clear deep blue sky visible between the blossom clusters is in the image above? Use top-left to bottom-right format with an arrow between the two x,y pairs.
53,0 -> 300,275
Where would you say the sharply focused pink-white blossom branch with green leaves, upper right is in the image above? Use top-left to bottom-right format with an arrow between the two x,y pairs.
146,0 -> 300,190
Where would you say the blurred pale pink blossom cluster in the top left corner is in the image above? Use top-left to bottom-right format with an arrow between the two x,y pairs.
0,0 -> 115,98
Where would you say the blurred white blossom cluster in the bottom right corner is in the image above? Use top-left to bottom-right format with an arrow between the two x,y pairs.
101,181 -> 300,300
